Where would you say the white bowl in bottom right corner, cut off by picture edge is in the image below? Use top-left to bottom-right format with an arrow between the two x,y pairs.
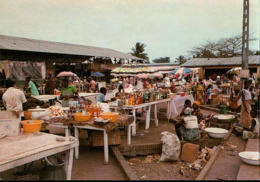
238,151 -> 260,165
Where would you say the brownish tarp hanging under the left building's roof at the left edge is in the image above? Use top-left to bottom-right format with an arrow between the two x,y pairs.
0,60 -> 46,80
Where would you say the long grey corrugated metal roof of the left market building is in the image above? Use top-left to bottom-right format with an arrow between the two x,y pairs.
0,35 -> 143,60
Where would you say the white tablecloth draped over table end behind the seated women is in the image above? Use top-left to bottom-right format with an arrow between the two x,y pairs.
170,95 -> 194,118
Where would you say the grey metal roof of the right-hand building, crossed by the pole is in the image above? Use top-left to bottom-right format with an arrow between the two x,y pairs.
181,55 -> 260,67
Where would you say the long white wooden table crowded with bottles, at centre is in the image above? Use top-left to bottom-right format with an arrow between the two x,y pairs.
109,98 -> 172,136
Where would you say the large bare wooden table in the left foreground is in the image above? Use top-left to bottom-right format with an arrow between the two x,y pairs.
0,132 -> 79,180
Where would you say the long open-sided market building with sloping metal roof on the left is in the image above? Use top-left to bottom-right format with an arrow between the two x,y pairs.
0,35 -> 145,84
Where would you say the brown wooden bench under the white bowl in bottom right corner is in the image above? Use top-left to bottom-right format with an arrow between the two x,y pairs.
237,139 -> 260,180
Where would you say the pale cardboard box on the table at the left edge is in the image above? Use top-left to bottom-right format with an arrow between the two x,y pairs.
0,111 -> 21,136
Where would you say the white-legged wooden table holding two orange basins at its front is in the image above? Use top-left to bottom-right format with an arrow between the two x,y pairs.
73,115 -> 134,164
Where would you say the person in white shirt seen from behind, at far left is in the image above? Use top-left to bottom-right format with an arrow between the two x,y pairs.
2,79 -> 27,118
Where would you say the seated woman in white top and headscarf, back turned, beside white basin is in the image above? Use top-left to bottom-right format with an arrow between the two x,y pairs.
175,107 -> 200,142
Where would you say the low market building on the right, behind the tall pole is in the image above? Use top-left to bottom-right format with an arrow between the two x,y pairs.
181,55 -> 260,79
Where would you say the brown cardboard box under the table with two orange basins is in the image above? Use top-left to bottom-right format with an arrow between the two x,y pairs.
90,130 -> 121,147
